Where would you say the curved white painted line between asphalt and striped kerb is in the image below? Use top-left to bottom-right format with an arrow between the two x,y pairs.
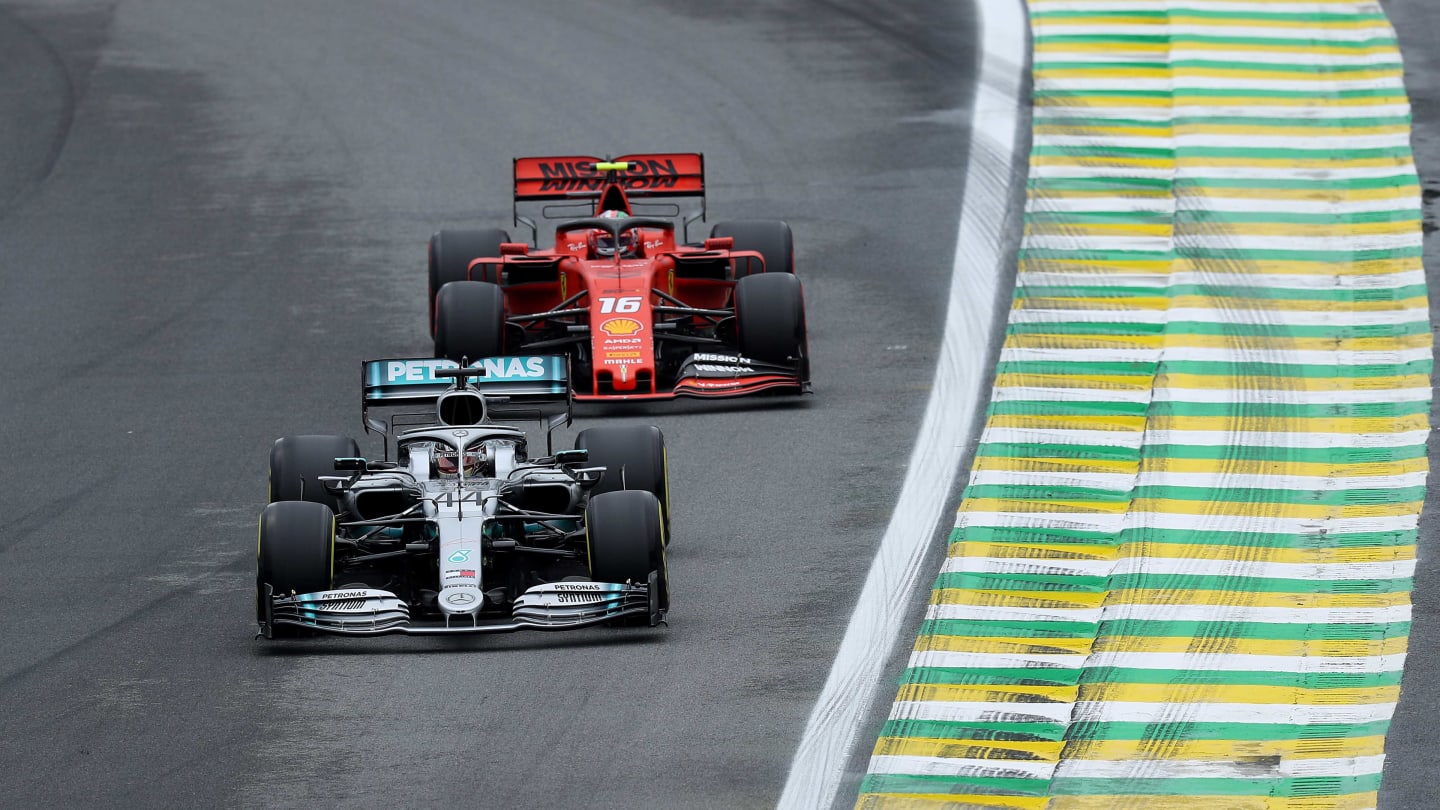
776,0 -> 1028,810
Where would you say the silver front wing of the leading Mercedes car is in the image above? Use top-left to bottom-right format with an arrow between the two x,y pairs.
256,574 -> 665,638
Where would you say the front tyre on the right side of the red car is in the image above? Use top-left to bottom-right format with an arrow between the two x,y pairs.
734,272 -> 809,368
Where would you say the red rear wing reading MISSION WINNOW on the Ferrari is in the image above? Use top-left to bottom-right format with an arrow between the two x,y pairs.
516,151 -> 706,200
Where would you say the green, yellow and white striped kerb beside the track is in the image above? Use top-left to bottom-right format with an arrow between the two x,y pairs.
858,0 -> 1433,810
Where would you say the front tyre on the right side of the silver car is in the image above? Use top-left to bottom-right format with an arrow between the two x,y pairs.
585,490 -> 670,611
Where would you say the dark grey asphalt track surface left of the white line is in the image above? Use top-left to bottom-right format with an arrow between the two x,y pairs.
0,0 -> 984,809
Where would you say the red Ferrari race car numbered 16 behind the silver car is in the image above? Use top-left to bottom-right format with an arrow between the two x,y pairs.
429,153 -> 809,399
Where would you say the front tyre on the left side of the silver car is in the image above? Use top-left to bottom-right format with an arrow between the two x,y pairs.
255,500 -> 336,636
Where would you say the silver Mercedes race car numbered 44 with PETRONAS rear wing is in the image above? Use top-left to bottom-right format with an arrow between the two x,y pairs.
256,356 -> 670,637
